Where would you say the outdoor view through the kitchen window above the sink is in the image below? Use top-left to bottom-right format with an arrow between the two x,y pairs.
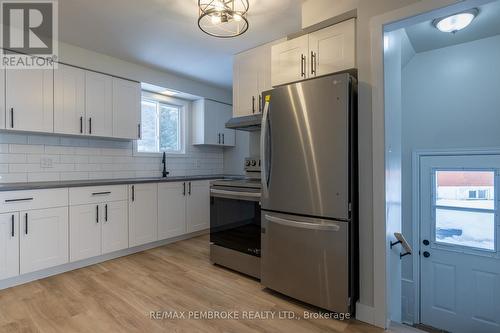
137,98 -> 183,153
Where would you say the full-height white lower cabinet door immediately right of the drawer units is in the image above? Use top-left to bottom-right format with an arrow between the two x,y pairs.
128,184 -> 158,247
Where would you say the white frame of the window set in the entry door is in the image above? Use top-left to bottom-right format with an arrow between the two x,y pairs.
430,167 -> 500,256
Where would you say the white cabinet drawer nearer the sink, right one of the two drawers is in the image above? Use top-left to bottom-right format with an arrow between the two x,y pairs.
69,185 -> 127,205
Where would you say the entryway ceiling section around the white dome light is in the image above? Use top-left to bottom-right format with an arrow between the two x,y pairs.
406,0 -> 500,53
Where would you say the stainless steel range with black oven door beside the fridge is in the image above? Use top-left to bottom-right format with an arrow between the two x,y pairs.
210,158 -> 261,278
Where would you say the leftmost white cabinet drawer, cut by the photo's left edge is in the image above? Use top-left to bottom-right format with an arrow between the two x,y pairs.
0,188 -> 68,213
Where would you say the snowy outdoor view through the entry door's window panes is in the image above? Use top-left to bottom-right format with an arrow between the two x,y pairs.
434,171 -> 496,251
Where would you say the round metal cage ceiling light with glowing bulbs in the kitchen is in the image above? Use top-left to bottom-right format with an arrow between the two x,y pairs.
198,0 -> 249,38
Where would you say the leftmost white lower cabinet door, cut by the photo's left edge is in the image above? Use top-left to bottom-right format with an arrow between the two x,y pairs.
0,213 -> 19,280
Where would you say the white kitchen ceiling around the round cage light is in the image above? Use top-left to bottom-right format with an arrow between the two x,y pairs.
59,0 -> 302,88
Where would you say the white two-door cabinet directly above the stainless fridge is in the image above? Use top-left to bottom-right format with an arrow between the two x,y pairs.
271,19 -> 356,87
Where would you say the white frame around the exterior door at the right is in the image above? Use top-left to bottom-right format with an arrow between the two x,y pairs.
411,148 -> 500,324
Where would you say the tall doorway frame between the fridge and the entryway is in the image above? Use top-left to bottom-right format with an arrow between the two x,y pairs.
370,0 -> 492,328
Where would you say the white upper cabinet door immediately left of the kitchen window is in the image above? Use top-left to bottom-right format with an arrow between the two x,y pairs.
113,78 -> 141,139
